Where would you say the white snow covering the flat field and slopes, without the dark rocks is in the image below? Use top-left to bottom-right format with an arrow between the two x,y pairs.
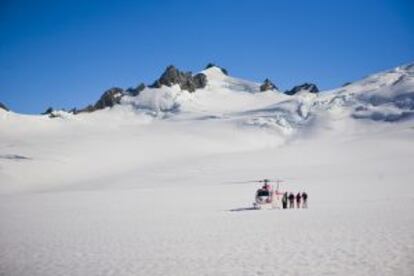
0,65 -> 414,276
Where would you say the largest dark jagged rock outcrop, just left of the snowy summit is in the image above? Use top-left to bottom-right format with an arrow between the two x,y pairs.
150,65 -> 207,92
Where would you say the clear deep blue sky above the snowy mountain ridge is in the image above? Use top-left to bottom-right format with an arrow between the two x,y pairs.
0,0 -> 414,113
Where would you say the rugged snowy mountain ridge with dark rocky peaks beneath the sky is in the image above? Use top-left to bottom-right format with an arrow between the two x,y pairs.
14,61 -> 414,133
